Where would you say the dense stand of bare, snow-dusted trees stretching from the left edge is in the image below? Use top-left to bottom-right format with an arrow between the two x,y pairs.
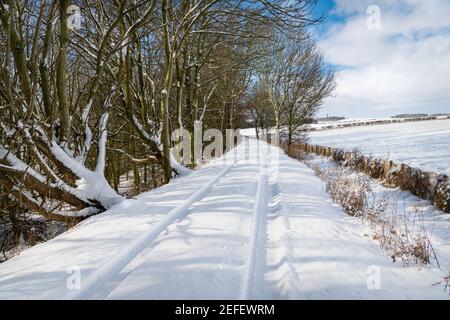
0,0 -> 333,225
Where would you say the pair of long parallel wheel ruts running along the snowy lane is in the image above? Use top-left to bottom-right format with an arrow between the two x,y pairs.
62,138 -> 270,300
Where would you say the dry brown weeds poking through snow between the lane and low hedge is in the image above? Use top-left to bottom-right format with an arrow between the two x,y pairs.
305,159 -> 439,266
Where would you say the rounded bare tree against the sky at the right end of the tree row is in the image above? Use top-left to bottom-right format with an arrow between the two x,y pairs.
259,29 -> 335,147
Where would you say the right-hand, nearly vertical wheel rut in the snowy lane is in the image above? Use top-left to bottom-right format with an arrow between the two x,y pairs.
240,142 -> 269,300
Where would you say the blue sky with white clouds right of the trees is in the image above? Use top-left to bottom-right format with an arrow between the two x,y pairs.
316,0 -> 450,117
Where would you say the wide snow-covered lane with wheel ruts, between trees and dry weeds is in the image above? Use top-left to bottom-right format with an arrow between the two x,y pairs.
0,139 -> 450,299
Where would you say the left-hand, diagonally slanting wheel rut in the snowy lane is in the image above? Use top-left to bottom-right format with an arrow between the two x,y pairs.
62,161 -> 237,300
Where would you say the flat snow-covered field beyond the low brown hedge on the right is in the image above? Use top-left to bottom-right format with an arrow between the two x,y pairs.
310,119 -> 450,175
